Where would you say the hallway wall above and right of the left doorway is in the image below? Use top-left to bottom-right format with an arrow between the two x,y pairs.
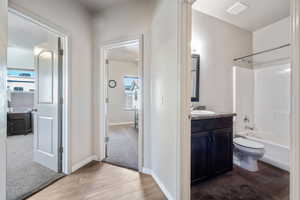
9,0 -> 93,165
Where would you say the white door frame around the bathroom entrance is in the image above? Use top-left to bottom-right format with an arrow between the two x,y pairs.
176,0 -> 300,200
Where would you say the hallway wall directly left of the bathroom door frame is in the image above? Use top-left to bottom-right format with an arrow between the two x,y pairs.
151,0 -> 180,199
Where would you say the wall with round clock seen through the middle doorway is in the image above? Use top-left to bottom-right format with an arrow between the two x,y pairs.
108,60 -> 138,124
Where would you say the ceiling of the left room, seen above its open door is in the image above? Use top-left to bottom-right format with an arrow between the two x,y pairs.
8,13 -> 49,49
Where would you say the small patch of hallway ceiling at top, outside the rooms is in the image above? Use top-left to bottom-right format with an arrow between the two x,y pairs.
77,0 -> 141,13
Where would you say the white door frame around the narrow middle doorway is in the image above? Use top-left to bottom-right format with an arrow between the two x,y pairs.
99,34 -> 144,172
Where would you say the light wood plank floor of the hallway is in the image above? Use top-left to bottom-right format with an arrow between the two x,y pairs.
28,162 -> 166,200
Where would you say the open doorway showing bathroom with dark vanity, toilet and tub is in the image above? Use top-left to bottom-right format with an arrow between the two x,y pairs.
191,0 -> 293,199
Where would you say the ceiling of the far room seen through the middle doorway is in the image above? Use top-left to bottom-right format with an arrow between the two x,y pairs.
108,44 -> 139,62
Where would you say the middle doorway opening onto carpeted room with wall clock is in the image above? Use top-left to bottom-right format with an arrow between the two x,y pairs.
102,38 -> 143,170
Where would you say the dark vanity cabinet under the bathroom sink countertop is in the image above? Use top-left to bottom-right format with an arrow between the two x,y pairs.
191,117 -> 233,184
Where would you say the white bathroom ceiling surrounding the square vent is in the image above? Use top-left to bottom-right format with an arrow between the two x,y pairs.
193,0 -> 290,31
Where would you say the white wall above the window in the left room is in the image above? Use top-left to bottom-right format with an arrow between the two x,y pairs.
7,47 -> 34,69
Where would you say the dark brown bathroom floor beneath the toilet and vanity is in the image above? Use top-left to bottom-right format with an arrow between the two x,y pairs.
191,162 -> 289,200
